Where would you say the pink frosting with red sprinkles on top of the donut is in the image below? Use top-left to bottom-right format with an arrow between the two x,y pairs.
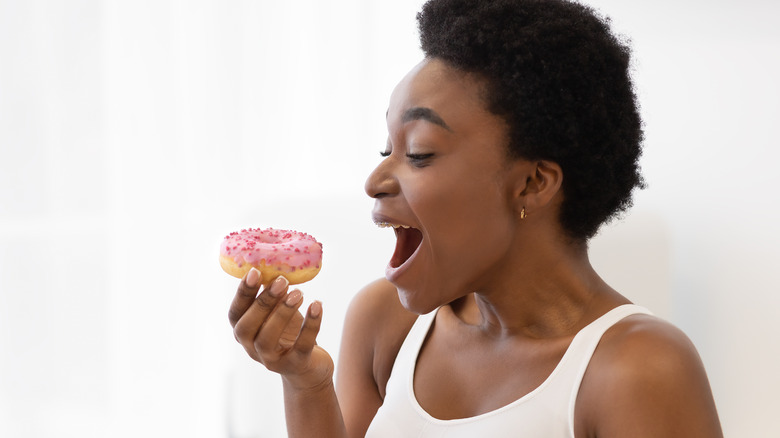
219,228 -> 322,272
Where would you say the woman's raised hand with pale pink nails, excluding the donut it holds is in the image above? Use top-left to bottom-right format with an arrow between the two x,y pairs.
228,268 -> 334,389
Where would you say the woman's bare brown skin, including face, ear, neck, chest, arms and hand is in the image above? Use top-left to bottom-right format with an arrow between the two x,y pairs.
230,59 -> 722,438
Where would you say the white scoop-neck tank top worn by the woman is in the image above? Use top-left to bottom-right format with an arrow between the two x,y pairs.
366,304 -> 650,438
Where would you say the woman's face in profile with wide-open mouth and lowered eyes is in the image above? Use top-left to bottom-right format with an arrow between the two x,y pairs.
366,59 -> 517,313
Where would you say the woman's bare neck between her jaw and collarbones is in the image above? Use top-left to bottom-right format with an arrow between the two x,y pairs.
452,233 -> 627,338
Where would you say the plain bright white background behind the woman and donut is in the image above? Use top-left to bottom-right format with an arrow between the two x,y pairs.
0,0 -> 780,438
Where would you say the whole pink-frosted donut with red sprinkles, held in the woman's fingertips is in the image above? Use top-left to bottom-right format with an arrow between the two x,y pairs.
219,228 -> 322,286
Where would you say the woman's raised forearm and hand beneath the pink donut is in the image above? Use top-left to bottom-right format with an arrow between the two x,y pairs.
228,269 -> 346,438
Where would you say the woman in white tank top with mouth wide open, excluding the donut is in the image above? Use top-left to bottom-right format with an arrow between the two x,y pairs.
230,0 -> 722,437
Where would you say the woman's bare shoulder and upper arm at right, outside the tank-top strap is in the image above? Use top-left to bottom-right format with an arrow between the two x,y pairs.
576,315 -> 721,437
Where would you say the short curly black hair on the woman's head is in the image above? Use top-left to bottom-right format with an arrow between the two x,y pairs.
417,0 -> 644,242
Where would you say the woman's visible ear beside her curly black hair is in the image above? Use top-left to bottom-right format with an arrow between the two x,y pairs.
514,160 -> 563,217
